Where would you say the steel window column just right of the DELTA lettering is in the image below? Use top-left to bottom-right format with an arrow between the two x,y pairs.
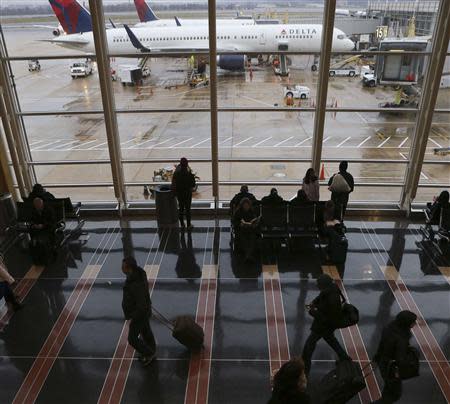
311,0 -> 336,174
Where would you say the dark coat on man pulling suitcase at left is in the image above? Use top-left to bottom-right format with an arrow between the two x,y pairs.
122,267 -> 152,320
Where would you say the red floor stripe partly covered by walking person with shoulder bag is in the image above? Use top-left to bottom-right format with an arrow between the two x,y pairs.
322,266 -> 381,404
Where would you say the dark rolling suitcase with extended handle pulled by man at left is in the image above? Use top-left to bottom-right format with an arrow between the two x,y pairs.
152,307 -> 205,351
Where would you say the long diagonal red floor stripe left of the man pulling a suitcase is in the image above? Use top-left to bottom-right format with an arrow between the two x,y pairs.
13,265 -> 101,404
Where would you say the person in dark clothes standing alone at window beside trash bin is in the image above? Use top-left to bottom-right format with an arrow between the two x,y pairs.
172,157 -> 195,228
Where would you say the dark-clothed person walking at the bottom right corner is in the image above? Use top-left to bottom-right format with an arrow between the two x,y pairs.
374,310 -> 417,404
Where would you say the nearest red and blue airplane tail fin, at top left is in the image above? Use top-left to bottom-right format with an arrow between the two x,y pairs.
49,0 -> 92,34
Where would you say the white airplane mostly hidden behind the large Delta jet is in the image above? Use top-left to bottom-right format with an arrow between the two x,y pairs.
134,0 -> 255,28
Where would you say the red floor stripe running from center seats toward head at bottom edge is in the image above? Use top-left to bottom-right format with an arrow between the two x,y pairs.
263,265 -> 290,376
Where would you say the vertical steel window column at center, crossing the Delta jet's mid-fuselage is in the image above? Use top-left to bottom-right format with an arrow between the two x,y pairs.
208,0 -> 219,212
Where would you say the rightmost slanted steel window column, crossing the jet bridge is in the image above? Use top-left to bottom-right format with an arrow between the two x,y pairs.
400,0 -> 450,212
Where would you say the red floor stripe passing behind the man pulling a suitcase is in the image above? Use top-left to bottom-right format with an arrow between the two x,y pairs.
97,265 -> 159,404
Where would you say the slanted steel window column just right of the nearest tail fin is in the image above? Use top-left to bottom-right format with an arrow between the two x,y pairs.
89,0 -> 126,208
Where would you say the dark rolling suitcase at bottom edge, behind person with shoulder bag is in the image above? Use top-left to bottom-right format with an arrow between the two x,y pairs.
318,360 -> 370,404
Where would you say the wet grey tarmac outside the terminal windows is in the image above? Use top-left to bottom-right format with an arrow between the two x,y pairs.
3,25 -> 450,202
